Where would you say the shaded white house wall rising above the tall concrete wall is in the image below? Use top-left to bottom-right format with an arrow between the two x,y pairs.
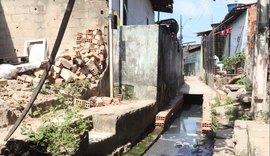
113,0 -> 155,25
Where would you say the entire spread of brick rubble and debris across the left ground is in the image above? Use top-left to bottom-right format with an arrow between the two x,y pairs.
0,29 -> 121,131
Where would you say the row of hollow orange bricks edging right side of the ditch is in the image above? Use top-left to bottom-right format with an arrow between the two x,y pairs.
201,95 -> 212,134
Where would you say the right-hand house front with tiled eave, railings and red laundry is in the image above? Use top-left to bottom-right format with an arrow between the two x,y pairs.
197,3 -> 257,87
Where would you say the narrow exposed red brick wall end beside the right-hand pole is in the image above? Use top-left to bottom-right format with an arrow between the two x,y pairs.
246,5 -> 257,78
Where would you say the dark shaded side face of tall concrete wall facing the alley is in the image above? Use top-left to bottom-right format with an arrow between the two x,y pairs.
157,27 -> 184,107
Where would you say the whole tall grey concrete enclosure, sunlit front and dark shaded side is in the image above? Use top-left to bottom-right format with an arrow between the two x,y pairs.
114,25 -> 183,106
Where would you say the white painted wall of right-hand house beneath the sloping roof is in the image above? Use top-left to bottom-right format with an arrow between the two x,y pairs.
230,11 -> 248,56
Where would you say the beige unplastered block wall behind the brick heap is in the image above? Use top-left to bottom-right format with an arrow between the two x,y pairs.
0,0 -> 108,57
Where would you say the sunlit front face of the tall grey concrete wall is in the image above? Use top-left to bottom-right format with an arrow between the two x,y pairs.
114,25 -> 159,99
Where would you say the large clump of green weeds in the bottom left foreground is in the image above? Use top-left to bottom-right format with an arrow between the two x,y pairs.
24,105 -> 91,155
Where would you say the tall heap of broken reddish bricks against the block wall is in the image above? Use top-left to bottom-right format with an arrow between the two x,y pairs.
50,29 -> 107,83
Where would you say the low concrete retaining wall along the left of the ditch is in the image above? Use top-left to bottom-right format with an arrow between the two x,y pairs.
85,100 -> 157,155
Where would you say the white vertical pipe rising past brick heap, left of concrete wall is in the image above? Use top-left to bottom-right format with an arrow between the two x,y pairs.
109,0 -> 113,98
